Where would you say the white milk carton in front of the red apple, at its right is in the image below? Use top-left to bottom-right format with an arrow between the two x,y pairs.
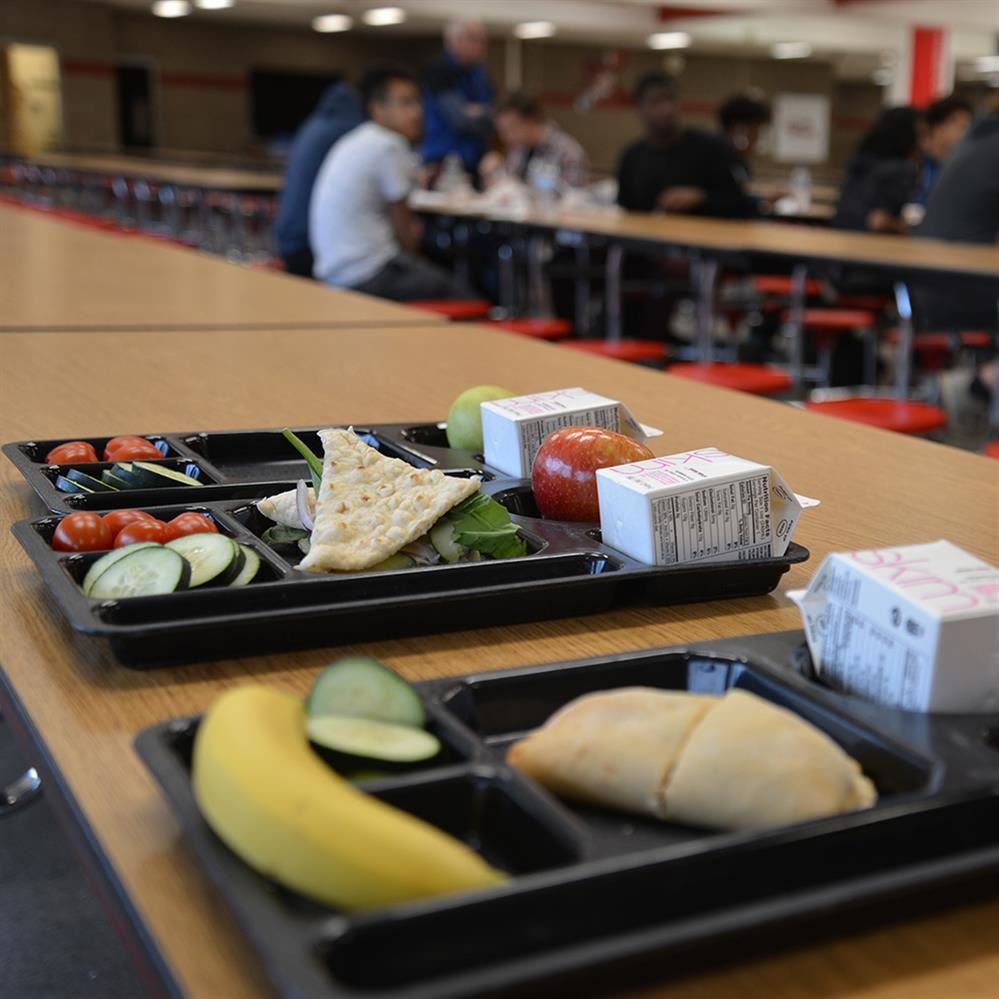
597,447 -> 818,565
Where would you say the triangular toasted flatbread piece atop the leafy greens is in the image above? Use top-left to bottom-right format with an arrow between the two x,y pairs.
300,430 -> 480,572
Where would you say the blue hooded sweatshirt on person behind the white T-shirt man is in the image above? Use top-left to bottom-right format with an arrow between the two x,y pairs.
274,83 -> 365,257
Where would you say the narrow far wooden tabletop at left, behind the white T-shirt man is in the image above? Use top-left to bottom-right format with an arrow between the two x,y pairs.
29,153 -> 284,194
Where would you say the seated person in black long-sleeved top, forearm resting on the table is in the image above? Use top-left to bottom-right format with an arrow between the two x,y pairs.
617,72 -> 756,218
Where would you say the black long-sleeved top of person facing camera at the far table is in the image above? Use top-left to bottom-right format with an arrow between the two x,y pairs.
617,128 -> 756,218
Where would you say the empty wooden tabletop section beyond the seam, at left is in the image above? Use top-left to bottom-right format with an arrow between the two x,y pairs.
0,205 -> 435,332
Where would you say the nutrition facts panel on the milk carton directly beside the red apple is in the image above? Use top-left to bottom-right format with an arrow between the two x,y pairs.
652,472 -> 772,565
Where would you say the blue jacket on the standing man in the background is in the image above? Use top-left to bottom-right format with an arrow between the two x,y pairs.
423,53 -> 493,173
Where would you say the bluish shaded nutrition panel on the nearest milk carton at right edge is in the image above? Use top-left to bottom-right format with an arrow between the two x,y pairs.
822,600 -> 932,708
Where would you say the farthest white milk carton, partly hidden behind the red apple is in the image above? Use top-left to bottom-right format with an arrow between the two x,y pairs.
481,388 -> 662,479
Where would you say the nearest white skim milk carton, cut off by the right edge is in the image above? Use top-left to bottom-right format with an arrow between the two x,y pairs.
788,541 -> 999,712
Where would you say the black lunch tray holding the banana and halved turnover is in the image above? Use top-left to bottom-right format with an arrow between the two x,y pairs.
136,632 -> 999,999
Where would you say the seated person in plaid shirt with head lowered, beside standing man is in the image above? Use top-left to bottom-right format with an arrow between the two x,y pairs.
496,93 -> 590,187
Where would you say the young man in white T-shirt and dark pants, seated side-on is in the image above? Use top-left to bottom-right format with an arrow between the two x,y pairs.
309,69 -> 470,301
